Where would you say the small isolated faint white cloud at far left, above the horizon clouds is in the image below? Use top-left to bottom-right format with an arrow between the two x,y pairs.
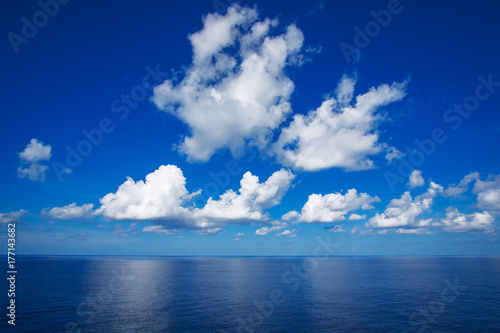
17,138 -> 52,182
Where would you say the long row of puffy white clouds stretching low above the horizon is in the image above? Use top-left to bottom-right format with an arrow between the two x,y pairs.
37,165 -> 500,237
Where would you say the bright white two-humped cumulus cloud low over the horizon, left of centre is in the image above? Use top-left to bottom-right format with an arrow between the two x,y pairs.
46,165 -> 295,234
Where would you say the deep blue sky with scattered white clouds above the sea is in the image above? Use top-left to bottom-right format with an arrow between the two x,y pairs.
0,0 -> 500,255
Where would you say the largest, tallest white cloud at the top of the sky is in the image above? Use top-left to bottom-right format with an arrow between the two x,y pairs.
153,5 -> 304,161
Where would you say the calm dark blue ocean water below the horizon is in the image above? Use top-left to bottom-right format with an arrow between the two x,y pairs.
0,256 -> 500,333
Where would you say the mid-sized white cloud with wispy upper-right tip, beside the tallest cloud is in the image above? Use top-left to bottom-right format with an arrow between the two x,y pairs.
273,76 -> 407,171
